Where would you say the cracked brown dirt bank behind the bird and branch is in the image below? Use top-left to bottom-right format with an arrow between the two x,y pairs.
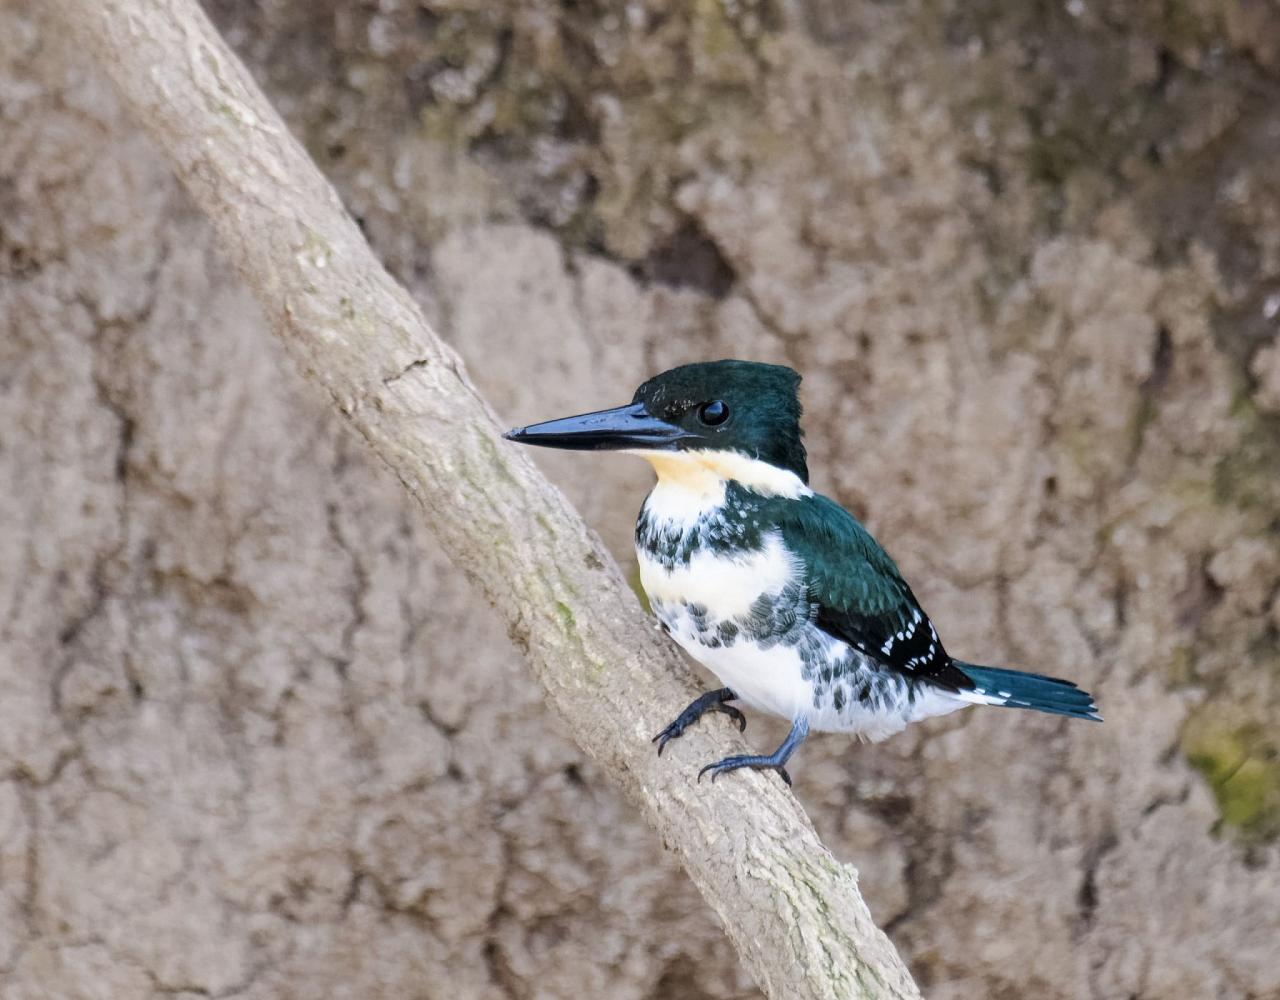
0,0 -> 1280,1000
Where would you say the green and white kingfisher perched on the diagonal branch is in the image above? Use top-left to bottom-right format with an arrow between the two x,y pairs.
506,360 -> 1101,785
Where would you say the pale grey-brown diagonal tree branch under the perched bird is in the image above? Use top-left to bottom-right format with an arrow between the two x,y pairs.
40,0 -> 918,1000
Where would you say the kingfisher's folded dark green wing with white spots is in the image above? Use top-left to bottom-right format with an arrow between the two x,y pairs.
778,494 -> 974,690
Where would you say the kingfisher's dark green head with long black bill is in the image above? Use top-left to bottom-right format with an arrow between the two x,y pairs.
504,361 -> 809,483
